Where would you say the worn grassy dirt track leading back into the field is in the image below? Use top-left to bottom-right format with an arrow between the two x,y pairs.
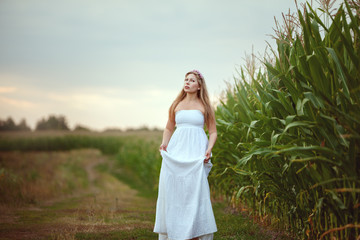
0,151 -> 156,239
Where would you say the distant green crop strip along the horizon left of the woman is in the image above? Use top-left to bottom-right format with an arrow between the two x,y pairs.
0,131 -> 162,155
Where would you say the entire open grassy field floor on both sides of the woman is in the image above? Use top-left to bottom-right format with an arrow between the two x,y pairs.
0,132 -> 287,239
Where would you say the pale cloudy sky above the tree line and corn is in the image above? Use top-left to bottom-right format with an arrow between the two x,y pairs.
0,0 -> 326,131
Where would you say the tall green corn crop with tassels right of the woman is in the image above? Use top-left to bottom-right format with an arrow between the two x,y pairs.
210,0 -> 360,239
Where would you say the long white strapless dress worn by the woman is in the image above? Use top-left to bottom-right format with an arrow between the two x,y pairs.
154,110 -> 217,240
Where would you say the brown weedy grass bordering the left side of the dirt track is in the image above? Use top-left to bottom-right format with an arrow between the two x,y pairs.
0,150 -> 94,206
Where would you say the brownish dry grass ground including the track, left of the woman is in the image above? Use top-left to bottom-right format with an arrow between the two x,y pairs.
0,150 -> 155,239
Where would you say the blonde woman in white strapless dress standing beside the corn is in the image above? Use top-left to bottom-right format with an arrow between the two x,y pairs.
154,70 -> 217,240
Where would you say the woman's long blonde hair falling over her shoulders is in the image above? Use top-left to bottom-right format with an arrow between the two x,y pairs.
169,70 -> 214,127
